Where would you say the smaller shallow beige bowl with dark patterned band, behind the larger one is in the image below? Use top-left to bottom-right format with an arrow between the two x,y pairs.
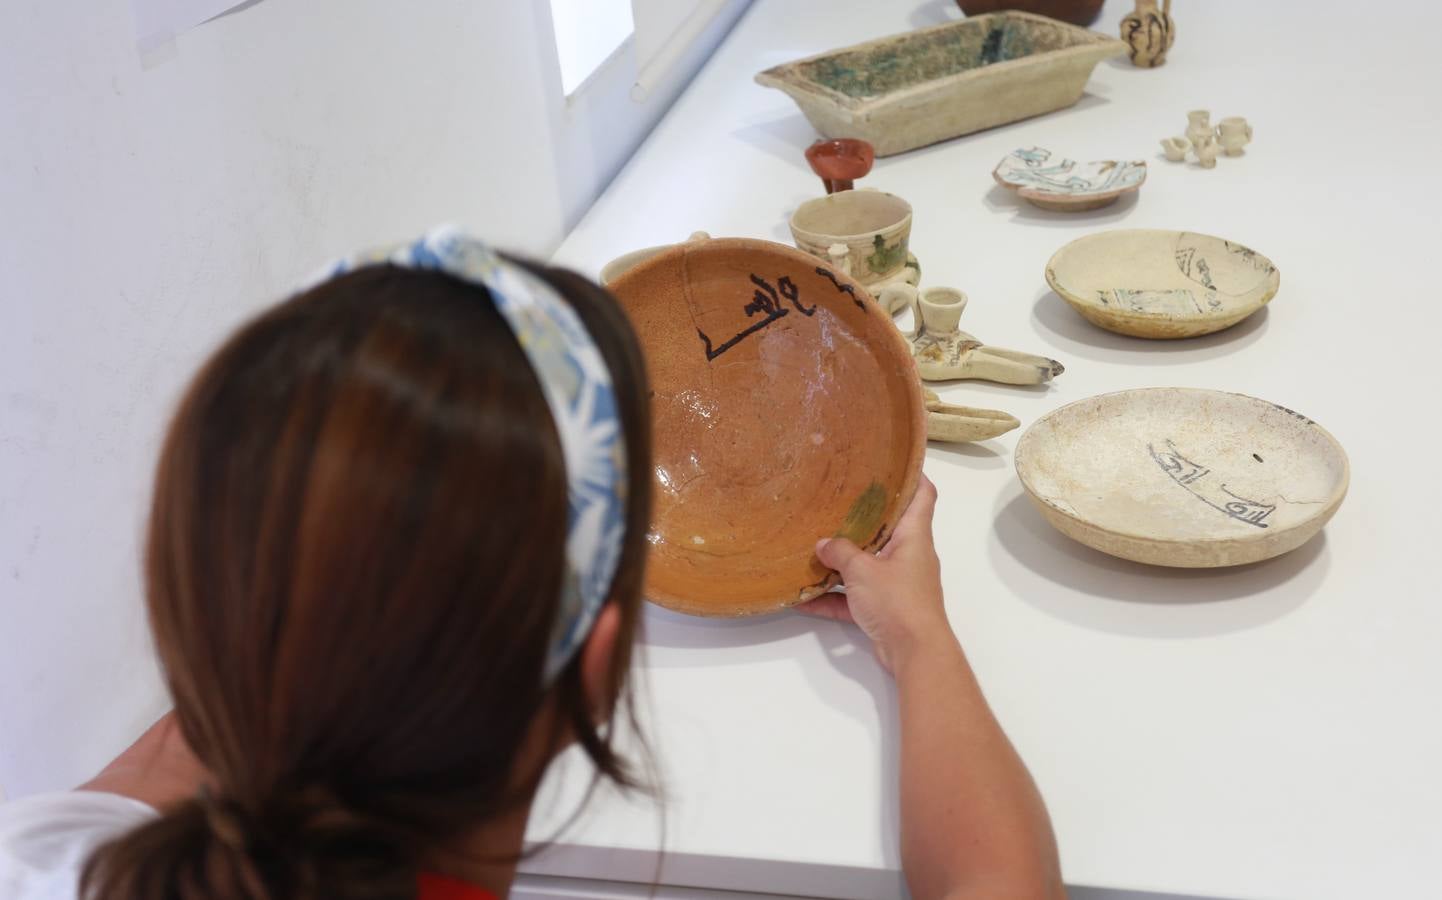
1047,229 -> 1282,338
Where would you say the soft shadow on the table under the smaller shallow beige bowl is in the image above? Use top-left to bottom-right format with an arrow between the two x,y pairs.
1031,288 -> 1269,365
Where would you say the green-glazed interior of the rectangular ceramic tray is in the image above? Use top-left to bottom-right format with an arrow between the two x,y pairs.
800,19 -> 1077,98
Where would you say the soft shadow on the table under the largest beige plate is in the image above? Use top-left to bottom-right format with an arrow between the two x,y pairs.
991,486 -> 1328,638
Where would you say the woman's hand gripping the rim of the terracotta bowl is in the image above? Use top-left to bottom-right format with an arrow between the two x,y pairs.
796,475 -> 956,672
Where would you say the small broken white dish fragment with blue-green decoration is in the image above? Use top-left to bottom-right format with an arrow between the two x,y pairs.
992,147 -> 1146,212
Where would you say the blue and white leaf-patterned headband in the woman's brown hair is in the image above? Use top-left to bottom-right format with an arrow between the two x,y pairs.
323,226 -> 626,684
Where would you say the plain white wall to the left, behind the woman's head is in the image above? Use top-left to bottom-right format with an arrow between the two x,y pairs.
0,0 -> 738,795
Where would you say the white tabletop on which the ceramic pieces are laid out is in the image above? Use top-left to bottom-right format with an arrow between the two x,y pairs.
526,0 -> 1442,899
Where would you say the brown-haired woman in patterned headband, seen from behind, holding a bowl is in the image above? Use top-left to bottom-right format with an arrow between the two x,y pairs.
0,229 -> 1061,900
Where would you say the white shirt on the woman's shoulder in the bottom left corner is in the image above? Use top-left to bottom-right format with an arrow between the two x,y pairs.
0,790 -> 157,900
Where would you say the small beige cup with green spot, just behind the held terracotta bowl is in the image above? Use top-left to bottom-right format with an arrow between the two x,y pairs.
790,188 -> 911,287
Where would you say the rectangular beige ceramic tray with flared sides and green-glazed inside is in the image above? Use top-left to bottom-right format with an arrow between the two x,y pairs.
756,12 -> 1126,156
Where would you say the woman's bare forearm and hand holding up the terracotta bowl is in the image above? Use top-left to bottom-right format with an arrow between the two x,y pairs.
803,479 -> 1066,900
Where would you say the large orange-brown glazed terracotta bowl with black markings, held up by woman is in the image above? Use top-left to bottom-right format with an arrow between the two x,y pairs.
610,238 -> 926,616
